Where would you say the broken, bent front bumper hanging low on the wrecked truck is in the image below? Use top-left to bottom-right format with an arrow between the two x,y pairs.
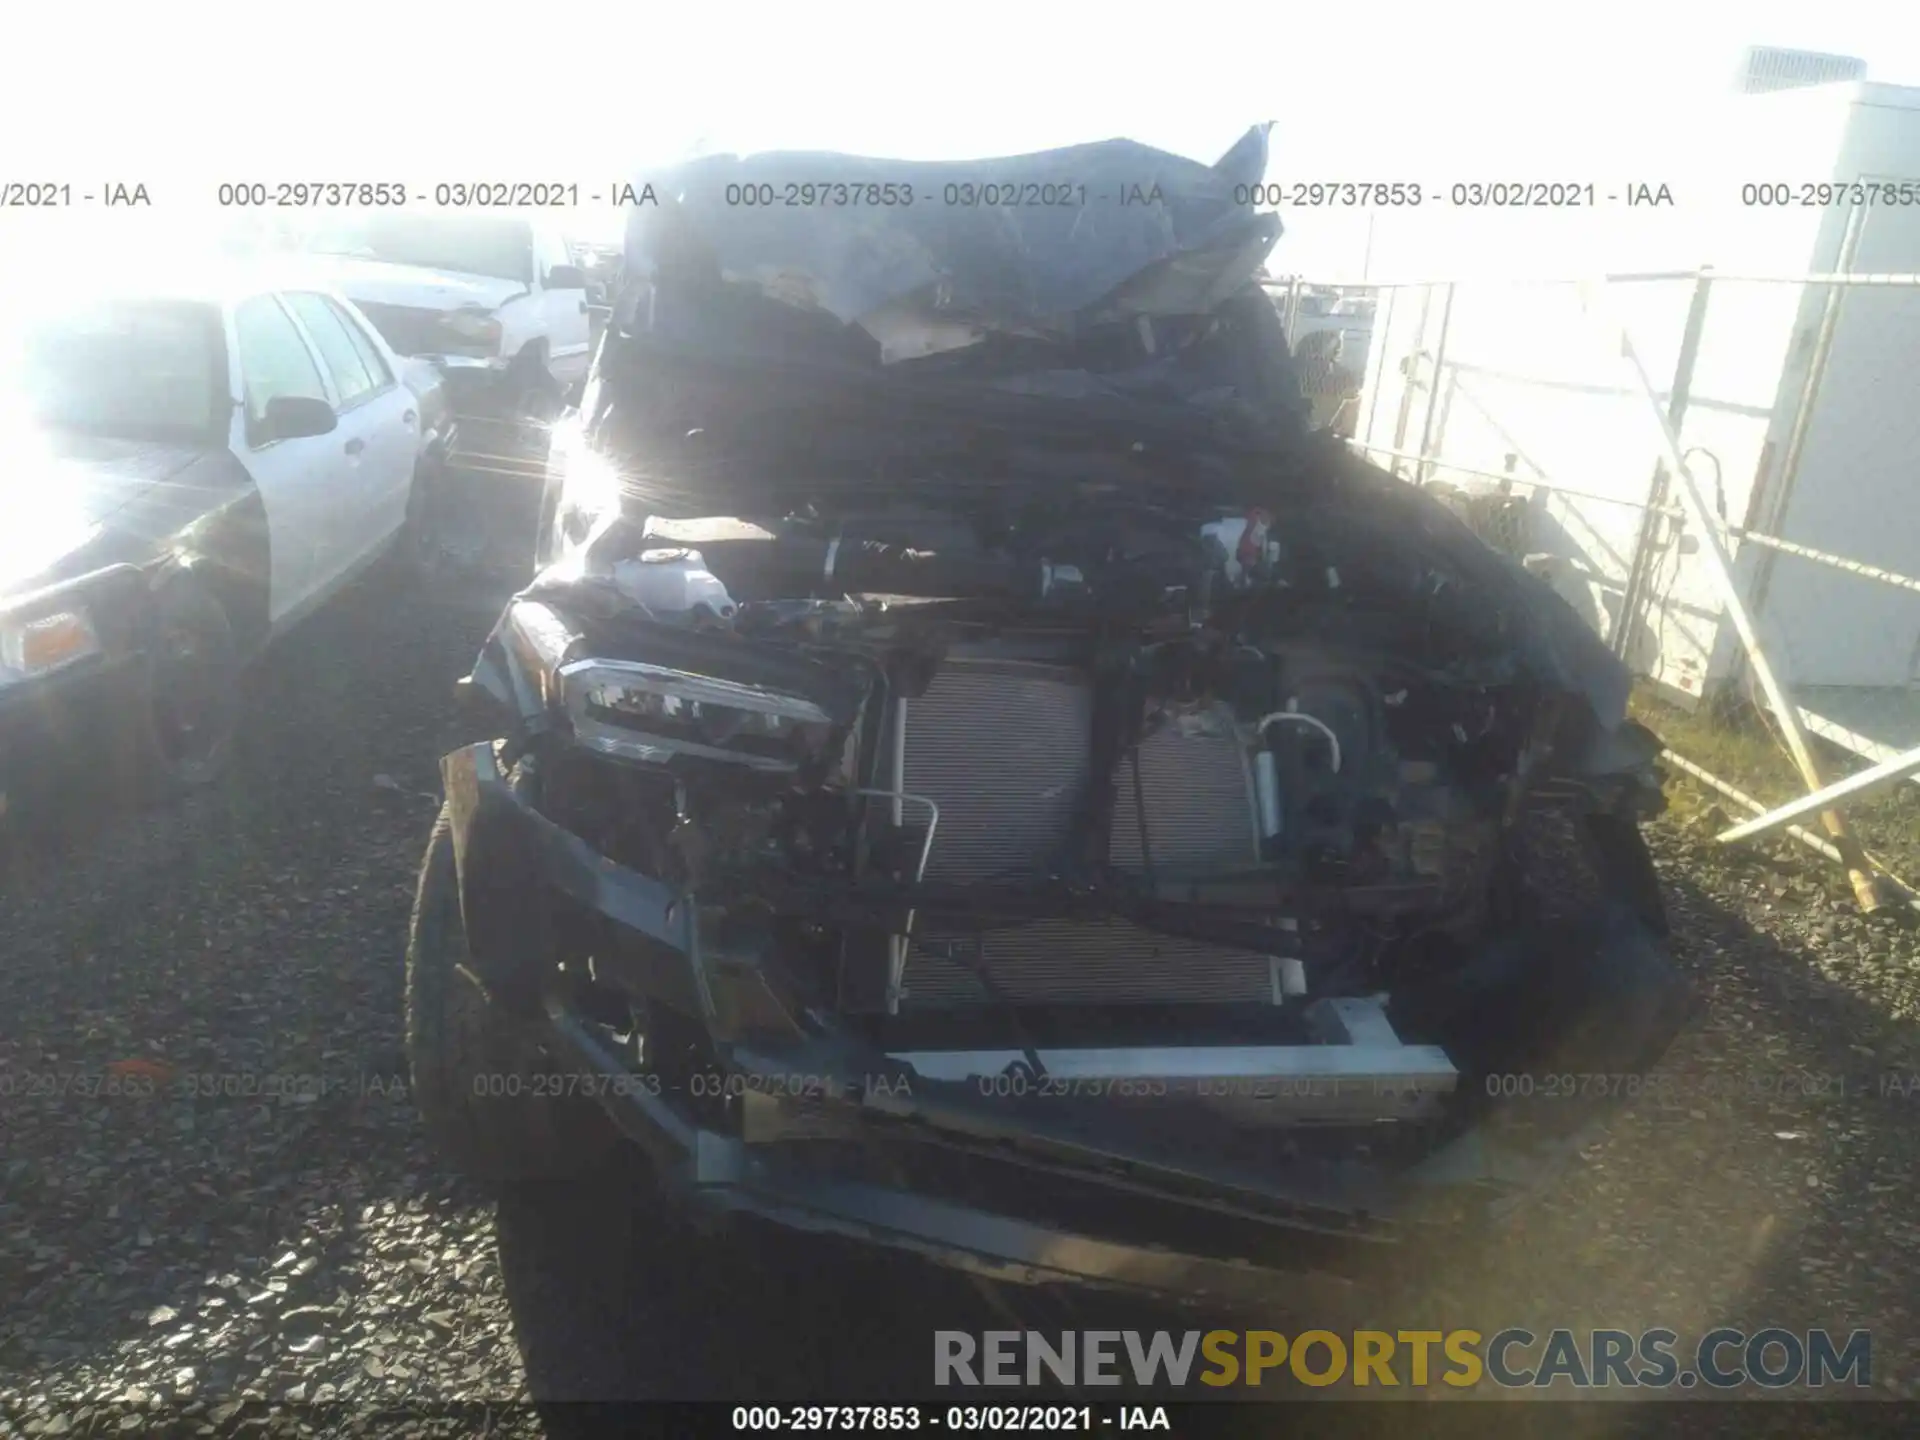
442,745 -> 1688,1304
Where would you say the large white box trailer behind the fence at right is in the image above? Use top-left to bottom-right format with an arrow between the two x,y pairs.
1359,83 -> 1920,758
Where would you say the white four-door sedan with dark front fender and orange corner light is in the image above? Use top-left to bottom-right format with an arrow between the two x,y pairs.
0,269 -> 447,799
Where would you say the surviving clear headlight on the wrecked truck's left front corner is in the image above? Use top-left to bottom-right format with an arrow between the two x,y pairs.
561,660 -> 833,770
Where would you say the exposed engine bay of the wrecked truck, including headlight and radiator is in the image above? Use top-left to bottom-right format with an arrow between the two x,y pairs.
476,457 -> 1657,1117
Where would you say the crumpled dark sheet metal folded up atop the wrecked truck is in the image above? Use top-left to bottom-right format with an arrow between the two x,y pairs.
626,125 -> 1281,353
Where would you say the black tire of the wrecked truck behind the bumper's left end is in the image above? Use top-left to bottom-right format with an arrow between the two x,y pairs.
407,806 -> 620,1187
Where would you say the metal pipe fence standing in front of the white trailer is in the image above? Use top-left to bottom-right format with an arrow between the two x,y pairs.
1271,264 -> 1920,902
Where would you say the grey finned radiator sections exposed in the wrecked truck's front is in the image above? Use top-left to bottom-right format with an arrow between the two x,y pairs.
883,659 -> 1279,1010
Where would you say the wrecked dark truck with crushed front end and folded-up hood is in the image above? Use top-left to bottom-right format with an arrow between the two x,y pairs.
407,129 -> 1690,1298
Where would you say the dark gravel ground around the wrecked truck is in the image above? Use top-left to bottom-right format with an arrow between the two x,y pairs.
0,564 -> 1920,1434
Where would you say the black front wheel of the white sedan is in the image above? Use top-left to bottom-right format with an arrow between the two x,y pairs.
127,576 -> 242,799
